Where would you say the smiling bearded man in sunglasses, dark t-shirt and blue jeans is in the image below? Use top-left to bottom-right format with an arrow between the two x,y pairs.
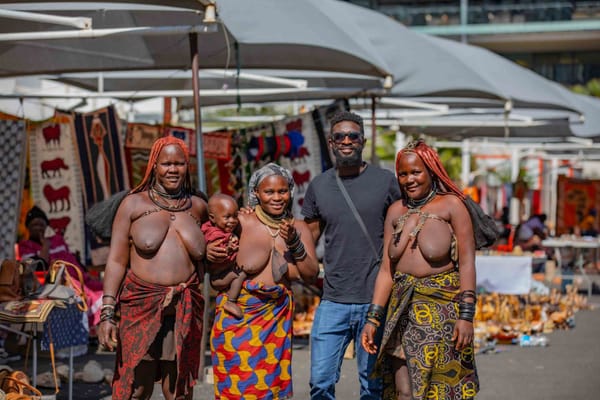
302,111 -> 401,400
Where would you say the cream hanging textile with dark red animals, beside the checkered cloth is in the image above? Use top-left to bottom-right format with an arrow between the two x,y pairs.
28,114 -> 86,257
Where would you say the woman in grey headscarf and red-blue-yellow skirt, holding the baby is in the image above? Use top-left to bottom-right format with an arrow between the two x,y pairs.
209,163 -> 318,399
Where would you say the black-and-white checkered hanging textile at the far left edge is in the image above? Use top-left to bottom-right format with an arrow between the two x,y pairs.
0,120 -> 26,259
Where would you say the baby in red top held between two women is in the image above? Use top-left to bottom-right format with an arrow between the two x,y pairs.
202,193 -> 246,318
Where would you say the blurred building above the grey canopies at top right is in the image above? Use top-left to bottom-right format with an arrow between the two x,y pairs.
349,0 -> 600,88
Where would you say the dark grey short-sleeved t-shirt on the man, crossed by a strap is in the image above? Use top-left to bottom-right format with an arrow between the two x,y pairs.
302,165 -> 401,304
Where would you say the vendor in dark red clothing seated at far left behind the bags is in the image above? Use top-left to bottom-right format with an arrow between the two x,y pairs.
18,206 -> 102,334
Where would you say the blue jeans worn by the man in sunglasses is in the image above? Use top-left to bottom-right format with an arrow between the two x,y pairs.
310,300 -> 382,400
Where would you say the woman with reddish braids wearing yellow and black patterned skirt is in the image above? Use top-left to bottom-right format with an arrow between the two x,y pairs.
362,141 -> 479,400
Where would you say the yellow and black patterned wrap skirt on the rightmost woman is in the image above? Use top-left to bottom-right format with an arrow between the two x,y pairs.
375,270 -> 479,400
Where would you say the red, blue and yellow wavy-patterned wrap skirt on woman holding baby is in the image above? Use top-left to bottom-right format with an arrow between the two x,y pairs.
210,281 -> 293,400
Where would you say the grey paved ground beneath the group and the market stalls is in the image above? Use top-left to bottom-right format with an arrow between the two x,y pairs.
2,296 -> 600,400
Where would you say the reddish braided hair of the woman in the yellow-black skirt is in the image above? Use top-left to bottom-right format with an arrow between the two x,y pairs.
396,139 -> 465,200
